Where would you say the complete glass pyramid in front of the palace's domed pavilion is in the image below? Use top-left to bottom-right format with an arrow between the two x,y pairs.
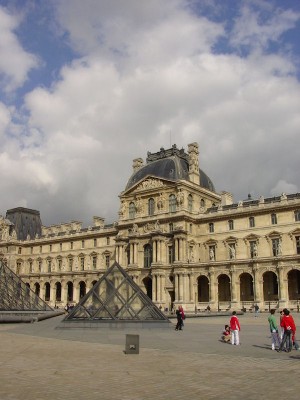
64,262 -> 169,322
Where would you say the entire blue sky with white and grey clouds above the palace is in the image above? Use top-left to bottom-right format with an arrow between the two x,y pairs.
0,0 -> 300,226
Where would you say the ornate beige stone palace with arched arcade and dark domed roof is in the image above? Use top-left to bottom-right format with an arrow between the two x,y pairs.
0,143 -> 300,312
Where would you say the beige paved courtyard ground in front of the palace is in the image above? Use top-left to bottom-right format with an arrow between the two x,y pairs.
0,314 -> 300,400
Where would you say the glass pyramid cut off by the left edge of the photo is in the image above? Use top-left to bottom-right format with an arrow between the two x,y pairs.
0,262 -> 53,311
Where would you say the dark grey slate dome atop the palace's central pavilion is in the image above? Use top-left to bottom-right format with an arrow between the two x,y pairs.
125,145 -> 215,192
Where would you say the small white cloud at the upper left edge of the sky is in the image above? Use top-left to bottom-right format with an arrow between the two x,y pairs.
0,7 -> 38,92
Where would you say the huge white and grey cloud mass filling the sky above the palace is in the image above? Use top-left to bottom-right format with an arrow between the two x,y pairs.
0,0 -> 300,223
